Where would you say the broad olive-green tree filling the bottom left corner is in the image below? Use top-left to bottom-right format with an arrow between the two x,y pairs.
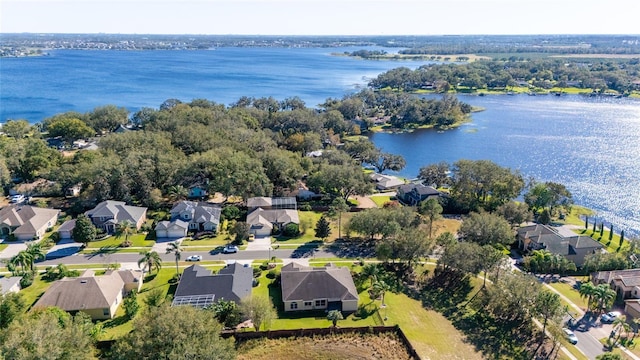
0,309 -> 96,360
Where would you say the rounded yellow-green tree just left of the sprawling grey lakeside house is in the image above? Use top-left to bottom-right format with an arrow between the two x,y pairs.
459,212 -> 515,245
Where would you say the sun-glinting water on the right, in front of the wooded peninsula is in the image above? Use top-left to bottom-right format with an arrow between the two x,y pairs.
371,95 -> 640,234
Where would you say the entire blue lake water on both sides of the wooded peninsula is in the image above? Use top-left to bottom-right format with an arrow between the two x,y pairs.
0,48 -> 640,234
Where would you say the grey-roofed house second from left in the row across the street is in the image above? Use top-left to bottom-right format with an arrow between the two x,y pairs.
85,200 -> 147,234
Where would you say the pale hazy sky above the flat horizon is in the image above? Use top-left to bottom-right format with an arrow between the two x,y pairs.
0,0 -> 640,35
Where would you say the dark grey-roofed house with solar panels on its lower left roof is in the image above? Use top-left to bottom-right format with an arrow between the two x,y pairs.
171,263 -> 253,308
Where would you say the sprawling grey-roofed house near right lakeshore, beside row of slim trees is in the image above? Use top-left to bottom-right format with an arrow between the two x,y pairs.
518,224 -> 604,267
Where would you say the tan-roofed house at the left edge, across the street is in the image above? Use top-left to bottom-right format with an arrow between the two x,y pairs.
0,204 -> 60,241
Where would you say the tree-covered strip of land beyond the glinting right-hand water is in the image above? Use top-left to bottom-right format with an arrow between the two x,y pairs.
369,58 -> 640,93
